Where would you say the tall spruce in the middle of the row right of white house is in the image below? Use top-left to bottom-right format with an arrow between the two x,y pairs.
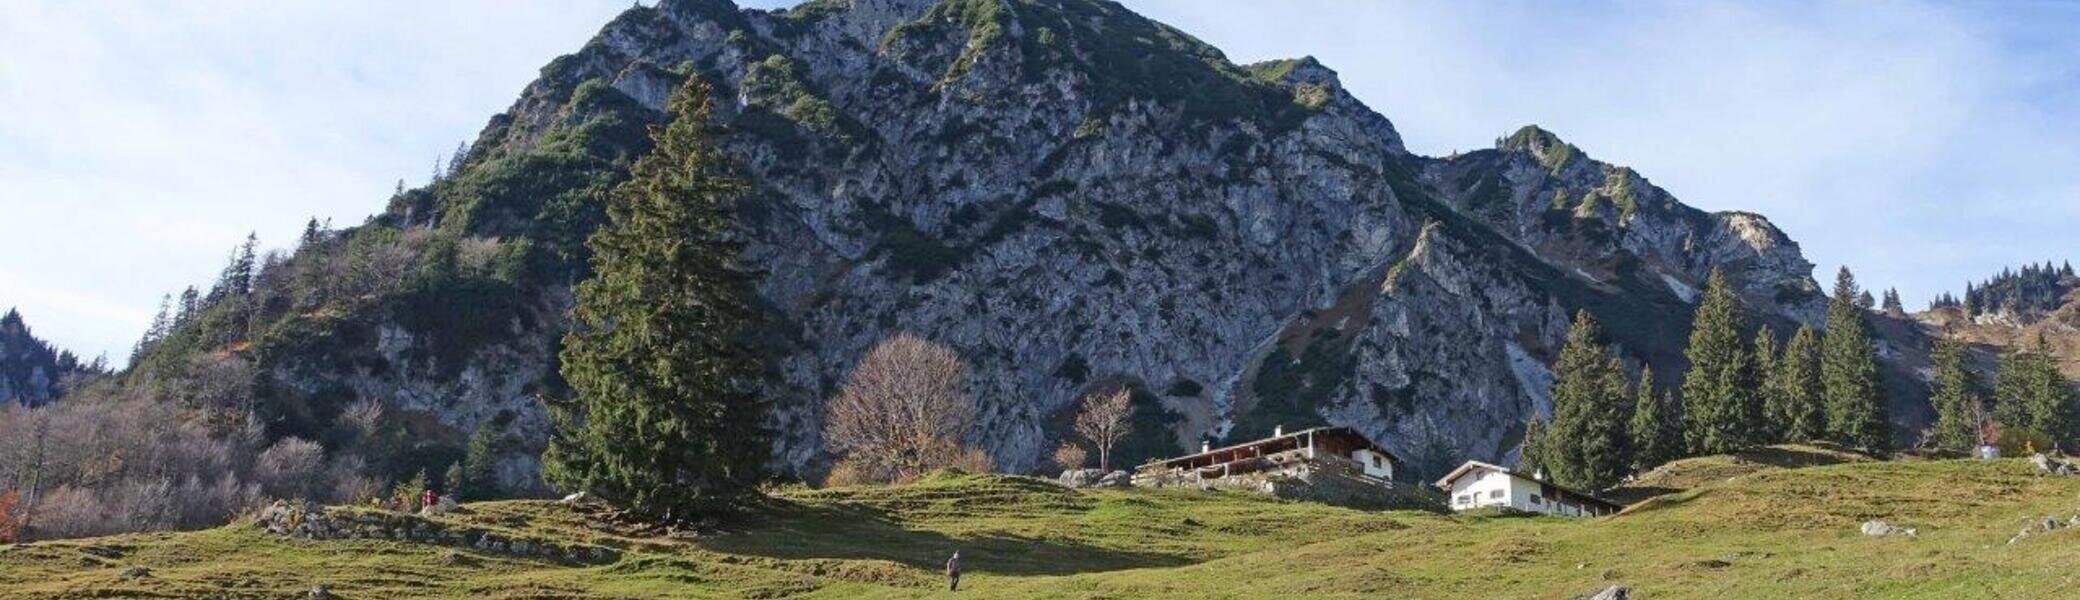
1683,269 -> 1762,454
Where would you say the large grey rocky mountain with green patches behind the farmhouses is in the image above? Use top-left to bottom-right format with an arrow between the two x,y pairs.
129,0 -> 1838,481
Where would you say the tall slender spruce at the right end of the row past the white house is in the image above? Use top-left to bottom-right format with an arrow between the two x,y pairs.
1820,267 -> 1893,454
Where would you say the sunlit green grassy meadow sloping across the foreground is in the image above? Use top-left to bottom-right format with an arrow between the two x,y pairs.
0,450 -> 2080,598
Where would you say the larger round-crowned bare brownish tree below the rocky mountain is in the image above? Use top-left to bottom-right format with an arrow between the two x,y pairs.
824,333 -> 986,481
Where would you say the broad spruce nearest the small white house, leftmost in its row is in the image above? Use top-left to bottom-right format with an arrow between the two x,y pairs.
1543,310 -> 1633,490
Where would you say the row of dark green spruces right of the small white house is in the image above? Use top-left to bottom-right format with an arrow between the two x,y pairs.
1520,269 -> 1905,490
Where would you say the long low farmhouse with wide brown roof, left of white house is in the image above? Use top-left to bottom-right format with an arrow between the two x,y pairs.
1134,427 -> 1398,502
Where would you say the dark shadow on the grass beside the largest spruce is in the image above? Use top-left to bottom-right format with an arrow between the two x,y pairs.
697,498 -> 1198,575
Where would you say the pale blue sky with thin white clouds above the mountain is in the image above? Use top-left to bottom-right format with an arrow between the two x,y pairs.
0,0 -> 2080,365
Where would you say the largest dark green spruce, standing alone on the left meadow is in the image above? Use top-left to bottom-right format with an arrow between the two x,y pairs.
543,77 -> 770,521
